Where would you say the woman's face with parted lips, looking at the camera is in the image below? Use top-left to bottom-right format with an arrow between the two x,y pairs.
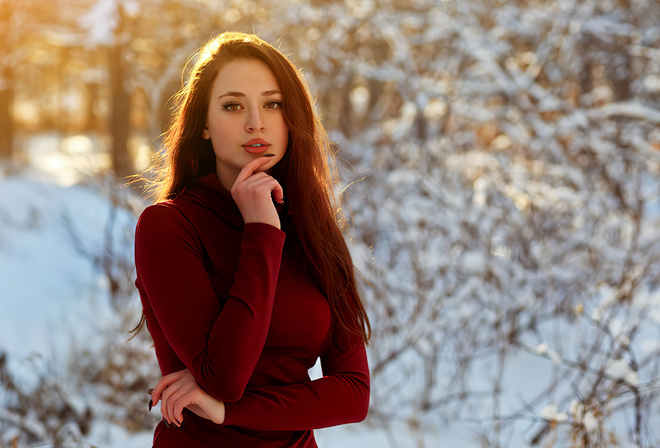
203,59 -> 288,190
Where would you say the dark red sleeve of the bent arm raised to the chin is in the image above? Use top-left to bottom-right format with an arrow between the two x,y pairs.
135,203 -> 285,402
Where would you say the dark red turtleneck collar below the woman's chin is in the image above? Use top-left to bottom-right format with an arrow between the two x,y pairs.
182,172 -> 245,229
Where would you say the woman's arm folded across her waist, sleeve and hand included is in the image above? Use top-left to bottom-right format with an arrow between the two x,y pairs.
147,324 -> 369,431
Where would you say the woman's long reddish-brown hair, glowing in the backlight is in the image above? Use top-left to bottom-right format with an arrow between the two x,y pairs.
136,32 -> 371,344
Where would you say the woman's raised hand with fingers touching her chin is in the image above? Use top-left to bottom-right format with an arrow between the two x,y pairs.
231,156 -> 284,229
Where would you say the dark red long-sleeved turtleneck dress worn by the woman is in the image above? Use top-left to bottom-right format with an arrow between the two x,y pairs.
135,173 -> 369,448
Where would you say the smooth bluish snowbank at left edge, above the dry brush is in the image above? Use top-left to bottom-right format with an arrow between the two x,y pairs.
0,178 -> 121,388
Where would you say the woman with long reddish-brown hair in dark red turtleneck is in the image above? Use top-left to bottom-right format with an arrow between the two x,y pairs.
135,33 -> 370,447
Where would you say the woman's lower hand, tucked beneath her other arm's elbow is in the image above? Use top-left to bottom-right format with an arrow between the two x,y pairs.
151,369 -> 225,426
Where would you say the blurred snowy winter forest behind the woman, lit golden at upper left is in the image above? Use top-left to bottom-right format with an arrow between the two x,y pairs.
0,0 -> 660,448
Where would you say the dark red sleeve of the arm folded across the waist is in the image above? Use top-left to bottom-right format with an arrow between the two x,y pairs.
224,326 -> 370,431
